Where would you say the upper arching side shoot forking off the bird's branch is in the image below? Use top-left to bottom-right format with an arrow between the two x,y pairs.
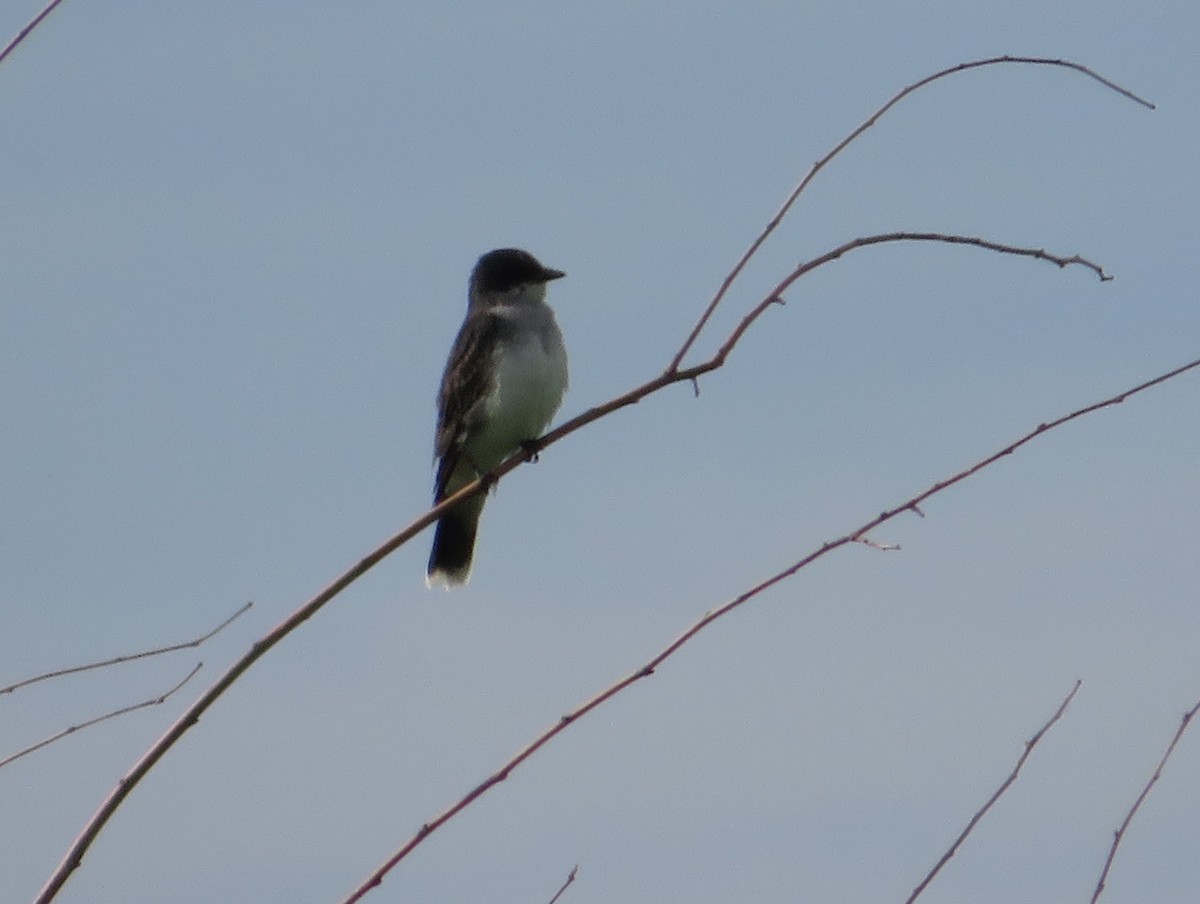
666,54 -> 1154,373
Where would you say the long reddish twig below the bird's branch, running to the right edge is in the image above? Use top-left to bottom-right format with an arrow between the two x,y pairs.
342,359 -> 1200,904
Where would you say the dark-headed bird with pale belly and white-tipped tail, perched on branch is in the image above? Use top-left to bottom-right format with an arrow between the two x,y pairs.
425,249 -> 566,589
